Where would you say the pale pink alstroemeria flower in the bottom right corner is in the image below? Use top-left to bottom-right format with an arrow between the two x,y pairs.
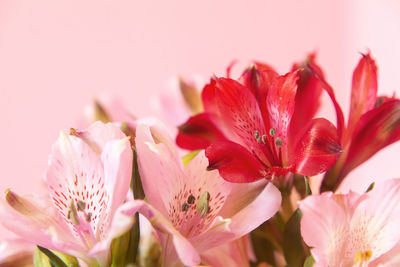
300,179 -> 400,267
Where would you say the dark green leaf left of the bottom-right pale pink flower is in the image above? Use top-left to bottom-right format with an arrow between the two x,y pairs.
283,209 -> 306,267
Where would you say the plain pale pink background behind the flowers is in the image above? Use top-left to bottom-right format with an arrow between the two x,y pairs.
0,0 -> 400,240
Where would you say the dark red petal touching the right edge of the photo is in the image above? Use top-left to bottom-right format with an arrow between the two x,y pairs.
341,100 -> 400,176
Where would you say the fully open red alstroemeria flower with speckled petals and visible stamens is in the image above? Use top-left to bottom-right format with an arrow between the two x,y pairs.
177,57 -> 341,183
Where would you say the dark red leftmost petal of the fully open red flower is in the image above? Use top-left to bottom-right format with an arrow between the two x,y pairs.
176,113 -> 225,150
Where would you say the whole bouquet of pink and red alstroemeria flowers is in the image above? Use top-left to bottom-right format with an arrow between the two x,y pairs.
0,54 -> 400,267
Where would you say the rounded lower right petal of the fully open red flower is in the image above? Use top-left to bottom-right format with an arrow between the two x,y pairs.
293,118 -> 342,176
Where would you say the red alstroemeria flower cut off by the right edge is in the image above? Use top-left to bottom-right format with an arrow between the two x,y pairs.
320,54 -> 400,191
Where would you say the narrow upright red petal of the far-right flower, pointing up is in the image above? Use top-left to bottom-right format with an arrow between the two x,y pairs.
347,54 -> 378,139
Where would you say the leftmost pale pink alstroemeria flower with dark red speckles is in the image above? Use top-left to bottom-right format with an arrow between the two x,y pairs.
0,122 -> 133,266
